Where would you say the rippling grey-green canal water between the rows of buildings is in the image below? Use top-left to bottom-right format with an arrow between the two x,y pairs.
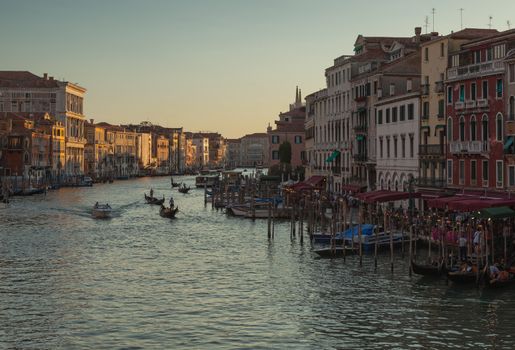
0,177 -> 515,349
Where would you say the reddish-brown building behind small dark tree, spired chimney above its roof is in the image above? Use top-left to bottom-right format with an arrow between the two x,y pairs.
267,88 -> 306,168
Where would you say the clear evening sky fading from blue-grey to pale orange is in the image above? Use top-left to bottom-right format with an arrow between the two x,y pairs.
0,0 -> 515,138
